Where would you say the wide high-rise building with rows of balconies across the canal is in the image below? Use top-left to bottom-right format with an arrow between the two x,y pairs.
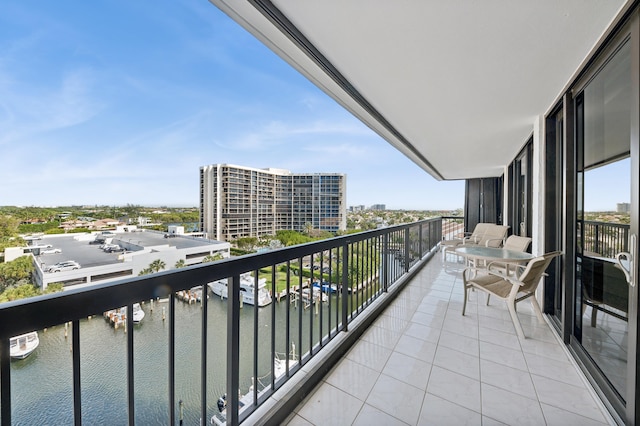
200,164 -> 347,240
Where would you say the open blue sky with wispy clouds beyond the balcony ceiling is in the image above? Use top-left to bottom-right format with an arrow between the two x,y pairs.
0,0 -> 464,210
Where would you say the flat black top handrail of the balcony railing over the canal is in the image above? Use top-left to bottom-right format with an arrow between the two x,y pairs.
0,218 -> 437,339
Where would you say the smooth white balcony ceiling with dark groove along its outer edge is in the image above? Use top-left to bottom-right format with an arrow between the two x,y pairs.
211,0 -> 626,179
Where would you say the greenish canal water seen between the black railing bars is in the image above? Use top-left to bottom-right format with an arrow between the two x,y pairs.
11,293 -> 339,425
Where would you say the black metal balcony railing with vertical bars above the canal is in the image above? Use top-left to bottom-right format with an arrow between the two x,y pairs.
0,218 -> 443,425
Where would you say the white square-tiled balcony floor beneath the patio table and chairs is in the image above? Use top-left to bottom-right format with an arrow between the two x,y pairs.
288,257 -> 614,426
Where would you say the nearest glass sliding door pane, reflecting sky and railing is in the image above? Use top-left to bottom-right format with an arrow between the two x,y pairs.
572,40 -> 638,415
